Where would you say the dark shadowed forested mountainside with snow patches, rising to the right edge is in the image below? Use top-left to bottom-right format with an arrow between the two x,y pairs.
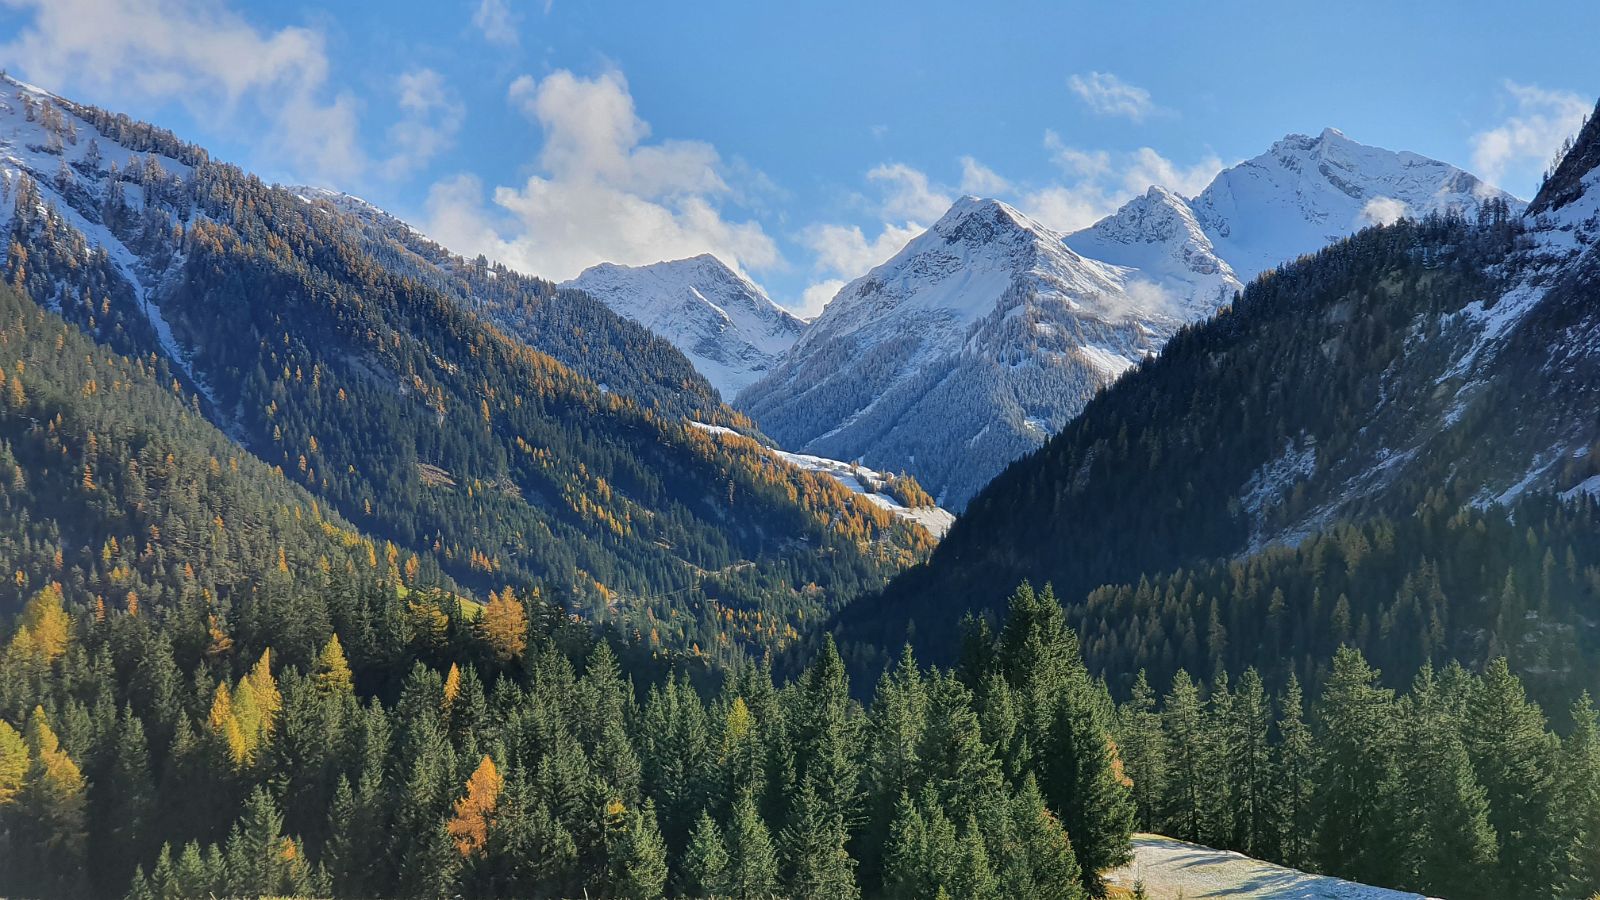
842,99 -> 1600,672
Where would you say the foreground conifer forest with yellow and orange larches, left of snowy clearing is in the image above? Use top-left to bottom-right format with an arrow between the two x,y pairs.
0,573 -> 1134,900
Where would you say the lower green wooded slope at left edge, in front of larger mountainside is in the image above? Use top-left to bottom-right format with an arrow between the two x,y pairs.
0,277 -> 425,617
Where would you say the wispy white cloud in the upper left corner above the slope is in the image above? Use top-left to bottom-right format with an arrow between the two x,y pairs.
0,0 -> 368,179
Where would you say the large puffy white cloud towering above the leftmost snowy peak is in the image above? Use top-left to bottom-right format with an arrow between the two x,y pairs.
427,70 -> 782,280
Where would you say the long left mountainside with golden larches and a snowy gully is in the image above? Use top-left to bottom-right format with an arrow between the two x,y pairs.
0,75 -> 930,650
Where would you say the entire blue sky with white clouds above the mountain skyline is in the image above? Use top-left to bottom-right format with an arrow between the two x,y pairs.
0,0 -> 1600,312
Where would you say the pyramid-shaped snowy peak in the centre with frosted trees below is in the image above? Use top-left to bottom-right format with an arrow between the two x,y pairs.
739,197 -> 1186,506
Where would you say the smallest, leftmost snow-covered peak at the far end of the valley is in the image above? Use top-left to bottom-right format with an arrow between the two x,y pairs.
562,253 -> 805,393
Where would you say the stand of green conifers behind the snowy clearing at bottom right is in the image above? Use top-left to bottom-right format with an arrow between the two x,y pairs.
1115,647 -> 1600,900
